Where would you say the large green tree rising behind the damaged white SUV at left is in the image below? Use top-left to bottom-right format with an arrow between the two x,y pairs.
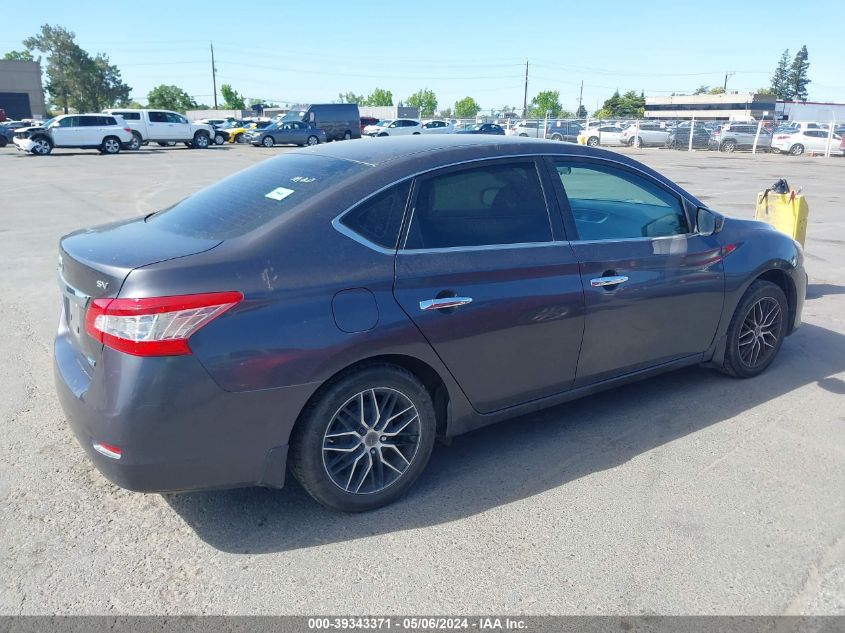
23,24 -> 131,113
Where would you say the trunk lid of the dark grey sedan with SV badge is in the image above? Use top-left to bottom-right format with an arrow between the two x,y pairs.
58,218 -> 222,358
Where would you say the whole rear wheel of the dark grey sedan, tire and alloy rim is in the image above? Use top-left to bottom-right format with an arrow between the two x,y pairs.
290,364 -> 436,512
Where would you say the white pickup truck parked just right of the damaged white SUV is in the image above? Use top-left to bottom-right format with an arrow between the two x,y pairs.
103,108 -> 214,149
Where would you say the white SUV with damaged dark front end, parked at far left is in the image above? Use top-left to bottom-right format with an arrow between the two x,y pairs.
12,114 -> 132,156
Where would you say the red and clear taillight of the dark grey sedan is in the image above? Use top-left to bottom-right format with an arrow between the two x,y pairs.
85,292 -> 243,356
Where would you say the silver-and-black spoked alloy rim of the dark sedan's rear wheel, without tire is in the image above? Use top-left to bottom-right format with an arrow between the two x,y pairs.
323,387 -> 421,494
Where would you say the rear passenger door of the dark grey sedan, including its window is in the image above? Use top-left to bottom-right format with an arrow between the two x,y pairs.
394,158 -> 584,413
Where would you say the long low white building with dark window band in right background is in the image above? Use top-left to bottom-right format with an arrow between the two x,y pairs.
645,92 -> 775,121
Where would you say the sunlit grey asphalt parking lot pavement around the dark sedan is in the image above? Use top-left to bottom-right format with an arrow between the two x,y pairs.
0,141 -> 845,614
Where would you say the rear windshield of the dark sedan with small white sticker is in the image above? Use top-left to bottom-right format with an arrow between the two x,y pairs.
147,154 -> 367,240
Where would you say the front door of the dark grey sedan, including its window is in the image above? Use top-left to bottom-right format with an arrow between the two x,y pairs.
551,159 -> 724,386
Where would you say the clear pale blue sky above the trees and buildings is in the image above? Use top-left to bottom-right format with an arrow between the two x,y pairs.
6,0 -> 845,111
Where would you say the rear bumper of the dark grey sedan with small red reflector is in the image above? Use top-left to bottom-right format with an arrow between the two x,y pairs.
54,318 -> 315,492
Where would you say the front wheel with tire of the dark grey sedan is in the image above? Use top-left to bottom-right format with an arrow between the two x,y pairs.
721,280 -> 789,378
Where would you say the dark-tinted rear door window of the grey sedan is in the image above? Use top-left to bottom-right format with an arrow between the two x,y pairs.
405,161 -> 552,249
